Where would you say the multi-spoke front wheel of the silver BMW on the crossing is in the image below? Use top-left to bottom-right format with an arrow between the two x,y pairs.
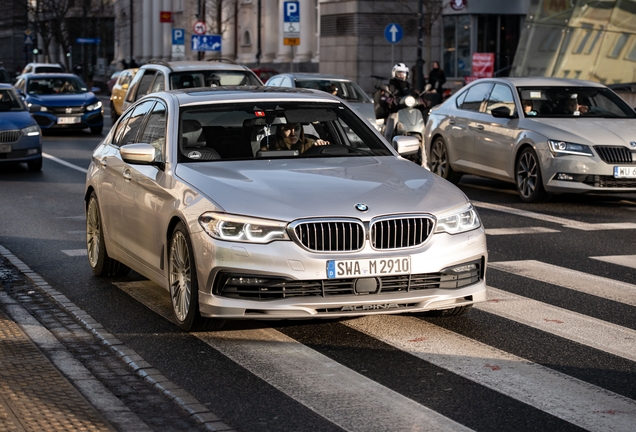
168,222 -> 224,331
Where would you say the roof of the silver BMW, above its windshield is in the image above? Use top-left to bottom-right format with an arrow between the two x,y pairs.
148,86 -> 342,106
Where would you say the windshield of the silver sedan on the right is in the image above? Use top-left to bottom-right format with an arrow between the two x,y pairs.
518,87 -> 636,118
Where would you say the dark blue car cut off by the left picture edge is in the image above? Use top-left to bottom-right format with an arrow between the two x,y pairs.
0,84 -> 42,171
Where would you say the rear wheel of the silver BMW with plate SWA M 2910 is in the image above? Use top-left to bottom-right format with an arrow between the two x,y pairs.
86,192 -> 130,276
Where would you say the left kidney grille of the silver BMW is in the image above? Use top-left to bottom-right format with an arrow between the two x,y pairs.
294,220 -> 364,252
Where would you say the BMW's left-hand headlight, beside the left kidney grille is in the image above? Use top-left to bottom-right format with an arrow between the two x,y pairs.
199,212 -> 289,243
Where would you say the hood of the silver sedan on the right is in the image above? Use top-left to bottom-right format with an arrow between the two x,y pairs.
526,117 -> 636,145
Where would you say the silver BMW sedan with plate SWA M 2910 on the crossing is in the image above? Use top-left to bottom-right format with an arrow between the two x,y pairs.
85,87 -> 487,330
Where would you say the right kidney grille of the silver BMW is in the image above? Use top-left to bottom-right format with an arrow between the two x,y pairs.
371,216 -> 434,249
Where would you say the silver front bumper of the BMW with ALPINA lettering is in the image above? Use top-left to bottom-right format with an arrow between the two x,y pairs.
192,228 -> 487,319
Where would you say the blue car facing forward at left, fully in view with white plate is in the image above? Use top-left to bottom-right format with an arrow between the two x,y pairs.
15,73 -> 104,134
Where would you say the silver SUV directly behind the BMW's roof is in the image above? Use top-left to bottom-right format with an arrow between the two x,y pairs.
122,60 -> 263,111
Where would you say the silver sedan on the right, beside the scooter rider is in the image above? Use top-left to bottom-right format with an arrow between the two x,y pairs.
424,78 -> 636,202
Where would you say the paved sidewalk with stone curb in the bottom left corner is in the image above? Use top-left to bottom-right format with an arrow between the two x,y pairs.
0,245 -> 234,432
